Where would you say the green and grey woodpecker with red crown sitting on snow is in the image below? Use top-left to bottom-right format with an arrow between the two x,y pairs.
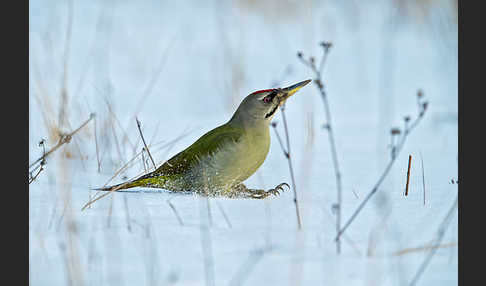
99,80 -> 311,198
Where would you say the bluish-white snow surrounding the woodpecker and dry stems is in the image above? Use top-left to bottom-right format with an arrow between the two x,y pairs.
29,0 -> 458,285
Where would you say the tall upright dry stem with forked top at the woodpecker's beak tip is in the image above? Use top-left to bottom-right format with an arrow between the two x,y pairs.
298,43 -> 342,253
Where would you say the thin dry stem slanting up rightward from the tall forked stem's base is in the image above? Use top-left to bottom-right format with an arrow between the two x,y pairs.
335,110 -> 423,241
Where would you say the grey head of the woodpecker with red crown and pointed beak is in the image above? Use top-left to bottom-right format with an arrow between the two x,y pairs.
231,79 -> 311,123
